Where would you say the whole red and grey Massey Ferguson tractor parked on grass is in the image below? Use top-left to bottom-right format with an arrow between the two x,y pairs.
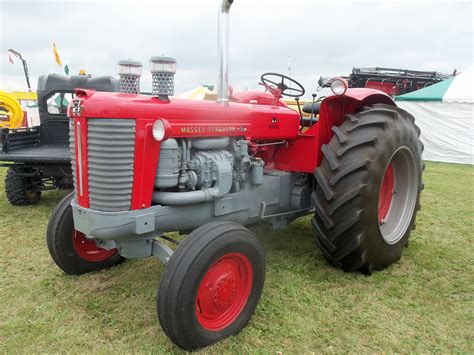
47,0 -> 423,350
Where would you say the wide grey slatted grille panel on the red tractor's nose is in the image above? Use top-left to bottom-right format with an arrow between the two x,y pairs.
87,118 -> 135,211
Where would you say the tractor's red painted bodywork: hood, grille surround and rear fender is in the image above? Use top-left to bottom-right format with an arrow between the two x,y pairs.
69,89 -> 394,209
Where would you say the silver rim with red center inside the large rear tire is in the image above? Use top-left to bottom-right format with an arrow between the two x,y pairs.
378,146 -> 418,244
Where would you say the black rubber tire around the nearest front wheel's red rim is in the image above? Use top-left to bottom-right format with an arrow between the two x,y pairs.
158,223 -> 265,350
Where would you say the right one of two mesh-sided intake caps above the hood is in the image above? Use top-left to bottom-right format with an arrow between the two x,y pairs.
150,56 -> 177,97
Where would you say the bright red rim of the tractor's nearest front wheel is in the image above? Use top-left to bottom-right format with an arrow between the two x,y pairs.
196,253 -> 253,331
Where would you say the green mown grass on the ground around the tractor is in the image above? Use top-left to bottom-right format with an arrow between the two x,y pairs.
0,163 -> 474,353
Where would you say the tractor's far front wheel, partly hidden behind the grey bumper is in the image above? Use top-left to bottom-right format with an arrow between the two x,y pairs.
46,192 -> 123,275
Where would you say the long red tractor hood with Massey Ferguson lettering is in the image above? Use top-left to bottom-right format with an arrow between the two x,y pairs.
68,89 -> 300,140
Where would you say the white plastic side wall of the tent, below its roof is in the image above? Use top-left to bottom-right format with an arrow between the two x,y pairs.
397,101 -> 474,164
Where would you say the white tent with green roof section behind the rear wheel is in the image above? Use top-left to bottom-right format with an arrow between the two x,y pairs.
395,68 -> 474,164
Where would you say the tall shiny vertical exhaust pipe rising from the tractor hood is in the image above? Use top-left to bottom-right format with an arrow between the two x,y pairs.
217,0 -> 234,106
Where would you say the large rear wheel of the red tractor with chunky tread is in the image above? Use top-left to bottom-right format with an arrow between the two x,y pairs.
312,104 -> 424,274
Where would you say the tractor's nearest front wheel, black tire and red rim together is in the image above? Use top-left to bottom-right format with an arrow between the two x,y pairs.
157,222 -> 265,350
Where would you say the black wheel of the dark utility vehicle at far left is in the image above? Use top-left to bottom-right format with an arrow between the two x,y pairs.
5,168 -> 41,206
